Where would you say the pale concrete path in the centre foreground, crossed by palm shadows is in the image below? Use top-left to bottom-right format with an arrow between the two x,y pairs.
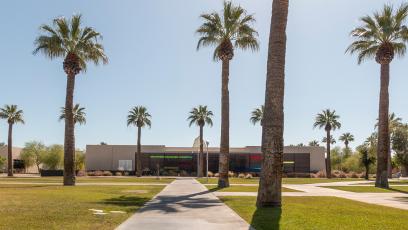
117,178 -> 253,230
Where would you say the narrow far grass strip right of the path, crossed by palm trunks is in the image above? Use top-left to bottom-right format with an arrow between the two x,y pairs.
197,178 -> 362,184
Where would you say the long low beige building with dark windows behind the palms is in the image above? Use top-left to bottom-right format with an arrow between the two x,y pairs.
85,145 -> 325,175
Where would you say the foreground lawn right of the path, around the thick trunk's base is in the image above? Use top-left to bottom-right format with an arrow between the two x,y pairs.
220,197 -> 408,230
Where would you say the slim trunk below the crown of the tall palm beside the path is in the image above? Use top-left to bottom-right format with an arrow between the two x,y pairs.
218,60 -> 229,188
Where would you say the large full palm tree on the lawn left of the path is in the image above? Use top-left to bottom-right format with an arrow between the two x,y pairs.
33,15 -> 108,185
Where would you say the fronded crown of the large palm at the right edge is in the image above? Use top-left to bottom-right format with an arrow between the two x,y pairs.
346,4 -> 408,64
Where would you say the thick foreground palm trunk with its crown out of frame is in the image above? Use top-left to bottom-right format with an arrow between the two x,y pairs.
257,0 -> 289,207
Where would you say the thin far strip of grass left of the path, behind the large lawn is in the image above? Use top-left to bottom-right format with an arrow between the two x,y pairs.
0,176 -> 174,184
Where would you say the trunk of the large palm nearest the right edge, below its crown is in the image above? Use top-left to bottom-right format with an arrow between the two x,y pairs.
375,64 -> 390,188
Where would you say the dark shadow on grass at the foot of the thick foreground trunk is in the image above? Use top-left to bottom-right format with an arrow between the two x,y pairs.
251,207 -> 282,230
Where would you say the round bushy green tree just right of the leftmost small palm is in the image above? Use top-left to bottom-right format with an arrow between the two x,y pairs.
21,141 -> 47,172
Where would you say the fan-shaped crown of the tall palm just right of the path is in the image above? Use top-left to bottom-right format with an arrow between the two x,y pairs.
197,1 -> 259,60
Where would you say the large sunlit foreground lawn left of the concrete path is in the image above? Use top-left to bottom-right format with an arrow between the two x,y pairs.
0,185 -> 164,230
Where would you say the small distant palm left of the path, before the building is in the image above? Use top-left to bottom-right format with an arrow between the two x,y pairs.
127,106 -> 152,177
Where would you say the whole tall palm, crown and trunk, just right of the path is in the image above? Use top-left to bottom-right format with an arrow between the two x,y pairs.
196,1 -> 259,188
